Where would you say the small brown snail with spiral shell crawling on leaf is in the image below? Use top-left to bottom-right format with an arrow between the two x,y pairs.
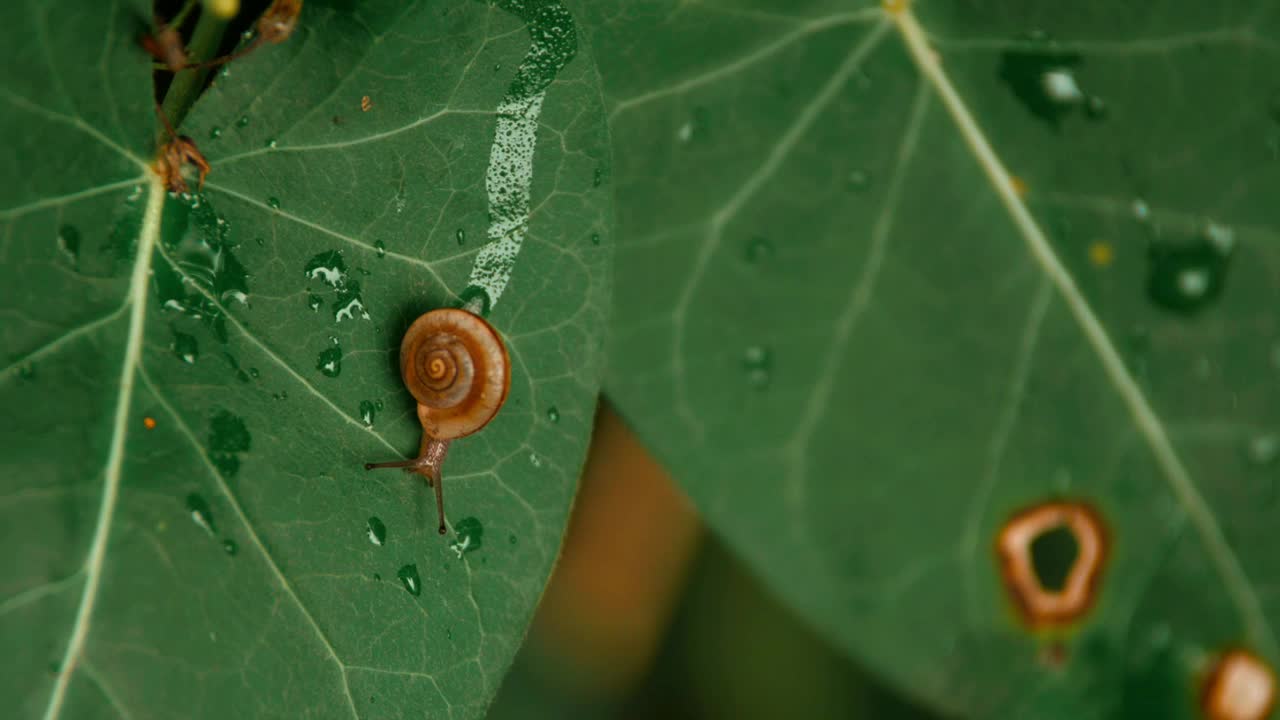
365,307 -> 511,536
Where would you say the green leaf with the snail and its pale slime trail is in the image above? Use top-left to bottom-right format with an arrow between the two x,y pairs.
0,0 -> 611,717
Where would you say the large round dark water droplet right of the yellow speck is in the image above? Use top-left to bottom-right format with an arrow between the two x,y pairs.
1147,237 -> 1230,315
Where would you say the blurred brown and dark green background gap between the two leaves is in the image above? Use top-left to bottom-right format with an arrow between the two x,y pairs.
489,405 -> 938,720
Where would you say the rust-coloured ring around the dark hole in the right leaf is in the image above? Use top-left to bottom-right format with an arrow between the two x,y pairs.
996,501 -> 1107,628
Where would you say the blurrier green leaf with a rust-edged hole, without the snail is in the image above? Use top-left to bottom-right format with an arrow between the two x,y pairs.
584,0 -> 1280,717
